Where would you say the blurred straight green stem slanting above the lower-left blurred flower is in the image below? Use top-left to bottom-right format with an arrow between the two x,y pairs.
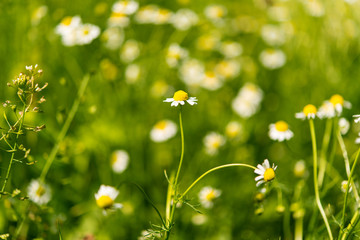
40,75 -> 90,181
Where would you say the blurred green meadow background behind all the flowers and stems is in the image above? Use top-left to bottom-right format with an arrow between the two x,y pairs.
0,0 -> 360,239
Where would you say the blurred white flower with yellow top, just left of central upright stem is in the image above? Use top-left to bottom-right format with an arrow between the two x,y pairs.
150,119 -> 177,142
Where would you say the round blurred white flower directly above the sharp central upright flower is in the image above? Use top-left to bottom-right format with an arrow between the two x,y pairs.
179,59 -> 205,86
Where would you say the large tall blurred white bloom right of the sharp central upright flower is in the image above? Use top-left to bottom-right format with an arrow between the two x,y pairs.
232,83 -> 263,118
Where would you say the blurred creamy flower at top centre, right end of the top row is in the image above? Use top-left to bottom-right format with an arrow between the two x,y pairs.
170,8 -> 199,31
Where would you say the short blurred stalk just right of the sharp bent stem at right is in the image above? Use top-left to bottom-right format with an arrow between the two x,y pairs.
318,118 -> 333,187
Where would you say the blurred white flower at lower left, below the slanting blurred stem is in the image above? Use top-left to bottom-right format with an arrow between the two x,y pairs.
27,179 -> 51,205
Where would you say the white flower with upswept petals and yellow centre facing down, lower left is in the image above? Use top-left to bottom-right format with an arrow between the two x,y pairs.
95,185 -> 122,215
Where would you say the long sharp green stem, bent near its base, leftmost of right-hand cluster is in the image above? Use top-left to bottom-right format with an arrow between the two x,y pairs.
309,119 -> 333,240
